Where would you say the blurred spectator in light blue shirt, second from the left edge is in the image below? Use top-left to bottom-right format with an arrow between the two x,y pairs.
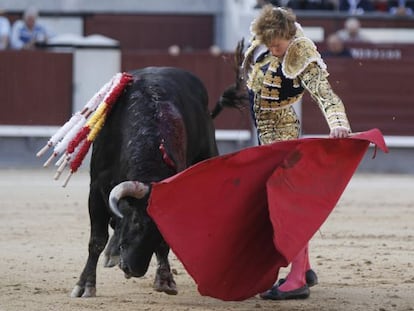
11,7 -> 49,50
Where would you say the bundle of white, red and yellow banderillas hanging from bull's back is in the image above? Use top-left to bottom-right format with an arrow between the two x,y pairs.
37,73 -> 133,187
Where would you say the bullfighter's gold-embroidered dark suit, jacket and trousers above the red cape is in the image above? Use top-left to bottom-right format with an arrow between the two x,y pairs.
243,32 -> 350,144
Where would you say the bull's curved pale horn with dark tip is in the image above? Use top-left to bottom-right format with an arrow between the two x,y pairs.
109,181 -> 149,218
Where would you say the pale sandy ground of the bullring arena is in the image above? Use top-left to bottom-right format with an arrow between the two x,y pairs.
0,169 -> 414,311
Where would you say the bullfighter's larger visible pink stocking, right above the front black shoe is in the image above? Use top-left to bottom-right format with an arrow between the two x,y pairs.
279,244 -> 310,292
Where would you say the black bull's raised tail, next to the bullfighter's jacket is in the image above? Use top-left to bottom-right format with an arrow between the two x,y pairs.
211,39 -> 248,119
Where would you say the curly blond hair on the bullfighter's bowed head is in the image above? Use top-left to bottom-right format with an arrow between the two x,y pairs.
252,4 -> 296,45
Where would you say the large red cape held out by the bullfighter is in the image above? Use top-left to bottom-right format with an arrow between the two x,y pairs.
148,129 -> 387,300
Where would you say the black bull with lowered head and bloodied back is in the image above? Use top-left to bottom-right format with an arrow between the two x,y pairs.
71,67 -> 247,297
